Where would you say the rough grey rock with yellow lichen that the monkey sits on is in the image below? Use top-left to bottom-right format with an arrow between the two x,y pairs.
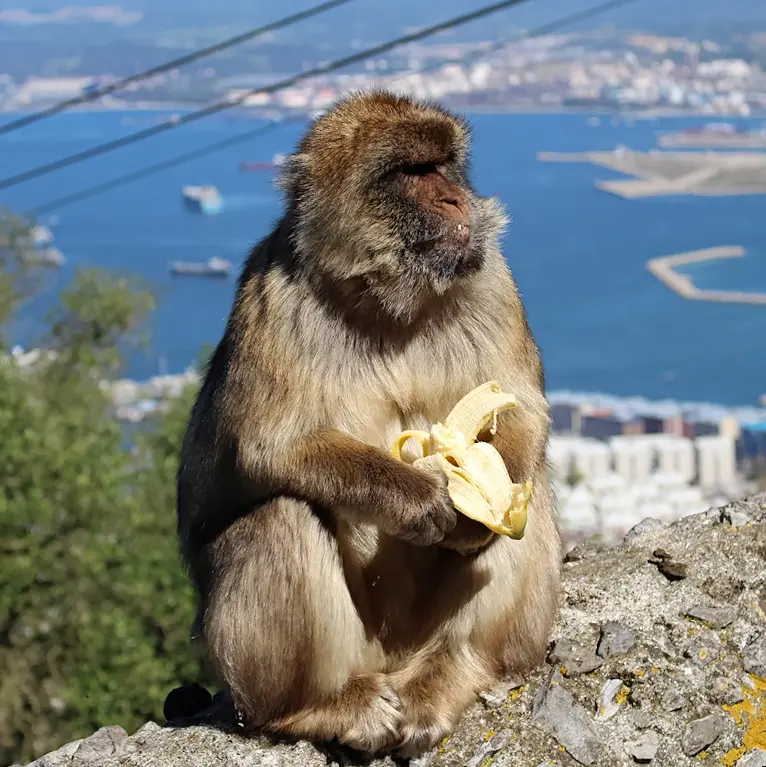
18,496 -> 766,767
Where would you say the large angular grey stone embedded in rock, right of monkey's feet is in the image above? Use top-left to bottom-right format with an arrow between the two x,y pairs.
532,671 -> 602,765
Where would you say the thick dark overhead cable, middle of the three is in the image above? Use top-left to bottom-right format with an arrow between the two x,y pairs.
0,0 -> 544,190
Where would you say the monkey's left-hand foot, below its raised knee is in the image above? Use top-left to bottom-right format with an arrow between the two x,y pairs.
278,674 -> 403,754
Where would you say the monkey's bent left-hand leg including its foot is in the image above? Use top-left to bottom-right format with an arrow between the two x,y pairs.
204,499 -> 401,751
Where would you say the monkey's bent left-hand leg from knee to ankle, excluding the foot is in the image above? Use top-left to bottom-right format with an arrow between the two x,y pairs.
203,499 -> 364,727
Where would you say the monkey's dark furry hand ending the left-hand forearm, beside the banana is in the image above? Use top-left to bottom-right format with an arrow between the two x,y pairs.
387,465 -> 457,546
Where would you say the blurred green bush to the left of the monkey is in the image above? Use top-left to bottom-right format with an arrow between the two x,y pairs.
0,208 -> 213,764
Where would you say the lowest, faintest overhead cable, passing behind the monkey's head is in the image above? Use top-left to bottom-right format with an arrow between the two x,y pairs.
30,0 -> 636,216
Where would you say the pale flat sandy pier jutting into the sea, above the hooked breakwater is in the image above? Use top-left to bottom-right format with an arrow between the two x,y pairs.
537,147 -> 766,199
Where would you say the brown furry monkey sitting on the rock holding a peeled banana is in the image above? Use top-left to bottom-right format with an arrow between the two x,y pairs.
177,89 -> 561,757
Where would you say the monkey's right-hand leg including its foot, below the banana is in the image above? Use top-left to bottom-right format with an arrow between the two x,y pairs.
390,488 -> 560,757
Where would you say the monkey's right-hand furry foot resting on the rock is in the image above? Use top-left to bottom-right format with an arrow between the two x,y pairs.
390,636 -> 491,758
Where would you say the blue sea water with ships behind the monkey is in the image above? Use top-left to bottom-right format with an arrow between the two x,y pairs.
0,112 -> 766,405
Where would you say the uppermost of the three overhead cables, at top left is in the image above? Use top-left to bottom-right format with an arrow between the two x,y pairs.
0,0 -> 360,136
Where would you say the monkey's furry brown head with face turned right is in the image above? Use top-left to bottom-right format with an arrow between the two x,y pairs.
283,91 -> 505,319
